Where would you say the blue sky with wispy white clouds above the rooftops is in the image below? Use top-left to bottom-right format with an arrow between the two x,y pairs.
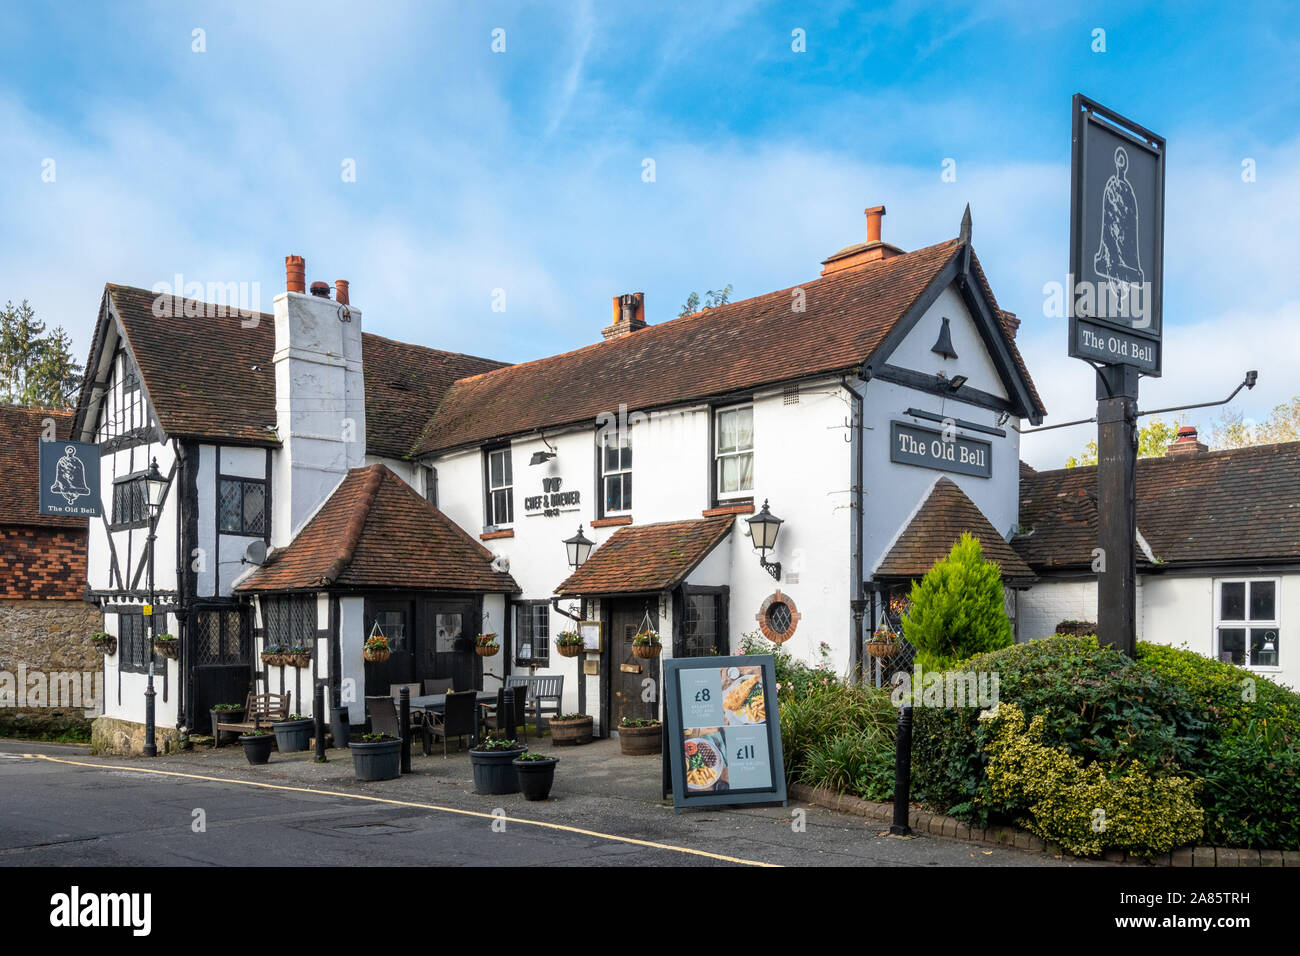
0,3 -> 1300,467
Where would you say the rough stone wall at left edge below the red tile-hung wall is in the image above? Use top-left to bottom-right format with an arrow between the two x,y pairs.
0,600 -> 104,737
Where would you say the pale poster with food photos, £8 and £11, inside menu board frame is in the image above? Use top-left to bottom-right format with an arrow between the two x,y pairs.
680,666 -> 772,795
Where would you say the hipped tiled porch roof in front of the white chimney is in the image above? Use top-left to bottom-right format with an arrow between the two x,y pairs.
235,464 -> 519,593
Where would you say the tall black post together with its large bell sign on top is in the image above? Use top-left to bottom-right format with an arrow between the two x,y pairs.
1069,94 -> 1165,657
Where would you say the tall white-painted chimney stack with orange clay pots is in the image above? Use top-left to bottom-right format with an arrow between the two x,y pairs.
270,256 -> 365,548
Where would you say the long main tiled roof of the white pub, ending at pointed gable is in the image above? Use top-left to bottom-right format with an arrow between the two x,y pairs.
415,239 -> 1041,454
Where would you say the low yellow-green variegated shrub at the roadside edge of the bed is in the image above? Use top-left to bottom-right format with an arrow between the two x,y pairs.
985,704 -> 1205,856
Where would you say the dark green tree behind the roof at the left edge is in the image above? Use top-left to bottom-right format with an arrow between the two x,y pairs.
0,299 -> 82,408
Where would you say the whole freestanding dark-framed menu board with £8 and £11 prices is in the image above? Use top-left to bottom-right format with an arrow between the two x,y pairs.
663,654 -> 787,812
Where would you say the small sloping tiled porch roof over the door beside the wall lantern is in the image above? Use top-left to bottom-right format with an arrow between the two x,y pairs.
555,515 -> 736,596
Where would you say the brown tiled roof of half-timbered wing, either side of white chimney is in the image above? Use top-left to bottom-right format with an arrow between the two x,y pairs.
91,284 -> 503,458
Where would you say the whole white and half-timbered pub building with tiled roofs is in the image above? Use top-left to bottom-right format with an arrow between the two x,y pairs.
73,206 -> 1044,750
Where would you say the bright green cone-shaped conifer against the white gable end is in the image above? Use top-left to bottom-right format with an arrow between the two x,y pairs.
902,533 -> 1015,670
